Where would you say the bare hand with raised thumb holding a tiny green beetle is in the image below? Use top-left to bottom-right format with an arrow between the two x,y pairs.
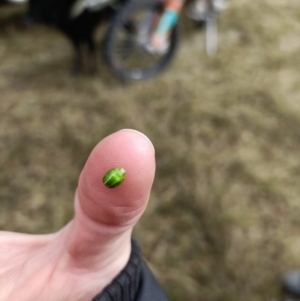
0,130 -> 155,301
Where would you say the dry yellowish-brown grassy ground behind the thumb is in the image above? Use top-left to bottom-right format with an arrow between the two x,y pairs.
0,0 -> 300,301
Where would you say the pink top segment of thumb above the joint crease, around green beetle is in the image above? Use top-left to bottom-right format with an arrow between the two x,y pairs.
76,130 -> 155,227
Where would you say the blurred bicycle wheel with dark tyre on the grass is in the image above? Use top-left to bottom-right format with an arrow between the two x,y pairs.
104,0 -> 179,80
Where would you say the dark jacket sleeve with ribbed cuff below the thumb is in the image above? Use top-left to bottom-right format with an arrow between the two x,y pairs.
92,240 -> 168,301
